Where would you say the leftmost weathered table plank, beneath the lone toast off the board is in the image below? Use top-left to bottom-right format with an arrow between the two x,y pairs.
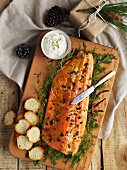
0,73 -> 18,170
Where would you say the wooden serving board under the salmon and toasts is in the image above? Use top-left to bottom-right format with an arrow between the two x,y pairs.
9,31 -> 119,170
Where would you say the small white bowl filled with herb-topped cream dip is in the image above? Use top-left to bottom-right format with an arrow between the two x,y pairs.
42,30 -> 70,59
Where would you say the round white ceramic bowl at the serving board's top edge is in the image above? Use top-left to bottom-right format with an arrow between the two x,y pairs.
41,30 -> 71,60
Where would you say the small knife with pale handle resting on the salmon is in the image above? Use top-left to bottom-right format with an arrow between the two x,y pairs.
71,71 -> 116,104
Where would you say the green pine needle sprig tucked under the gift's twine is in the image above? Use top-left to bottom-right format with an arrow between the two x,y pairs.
77,2 -> 127,33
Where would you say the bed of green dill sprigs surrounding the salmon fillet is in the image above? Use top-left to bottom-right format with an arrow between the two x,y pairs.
34,43 -> 115,168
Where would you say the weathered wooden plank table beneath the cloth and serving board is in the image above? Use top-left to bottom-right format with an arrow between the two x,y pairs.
0,0 -> 127,170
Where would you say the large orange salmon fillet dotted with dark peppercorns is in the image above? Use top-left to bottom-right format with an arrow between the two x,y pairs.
42,51 -> 93,155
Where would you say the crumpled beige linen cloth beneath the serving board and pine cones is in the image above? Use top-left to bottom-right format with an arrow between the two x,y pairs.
0,0 -> 127,139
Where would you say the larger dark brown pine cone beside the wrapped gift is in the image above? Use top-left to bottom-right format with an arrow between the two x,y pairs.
44,6 -> 67,27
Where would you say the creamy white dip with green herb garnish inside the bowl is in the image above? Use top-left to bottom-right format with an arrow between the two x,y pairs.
43,32 -> 67,59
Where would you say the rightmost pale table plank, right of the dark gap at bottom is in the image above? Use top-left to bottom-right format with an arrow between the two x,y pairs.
103,96 -> 127,170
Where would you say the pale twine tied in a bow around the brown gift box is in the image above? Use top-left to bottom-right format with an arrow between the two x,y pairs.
78,0 -> 108,37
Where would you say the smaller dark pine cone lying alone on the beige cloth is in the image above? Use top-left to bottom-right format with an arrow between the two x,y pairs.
16,44 -> 30,58
